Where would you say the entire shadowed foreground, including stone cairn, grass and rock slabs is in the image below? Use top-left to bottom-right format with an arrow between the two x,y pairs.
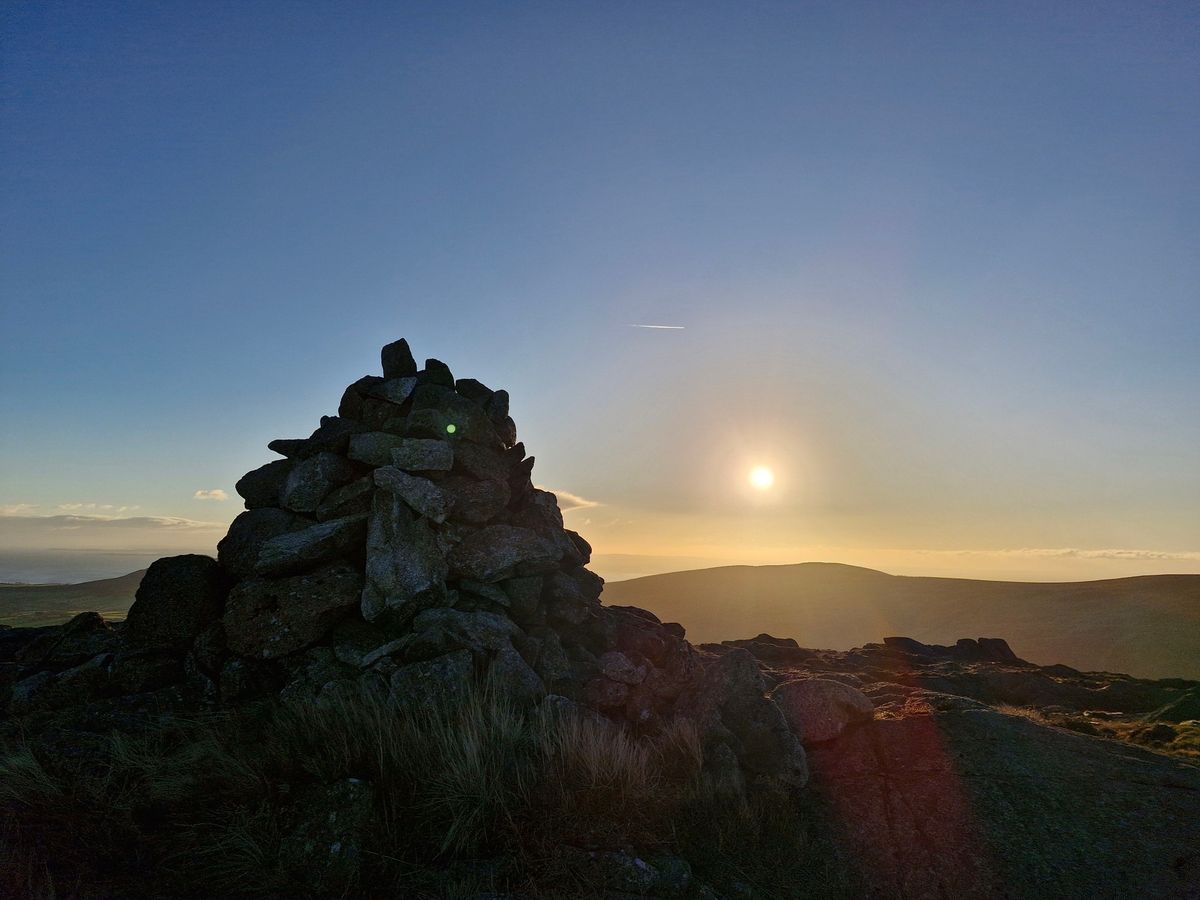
0,341 -> 1200,898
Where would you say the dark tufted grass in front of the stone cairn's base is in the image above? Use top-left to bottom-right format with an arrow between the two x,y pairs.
0,695 -> 850,898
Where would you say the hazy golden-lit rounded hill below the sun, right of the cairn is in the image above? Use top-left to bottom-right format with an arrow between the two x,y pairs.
602,563 -> 1200,678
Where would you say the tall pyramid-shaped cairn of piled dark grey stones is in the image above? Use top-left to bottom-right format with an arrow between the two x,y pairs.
4,340 -> 806,787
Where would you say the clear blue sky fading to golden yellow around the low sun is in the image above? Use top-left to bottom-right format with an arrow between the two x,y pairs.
0,1 -> 1200,578
